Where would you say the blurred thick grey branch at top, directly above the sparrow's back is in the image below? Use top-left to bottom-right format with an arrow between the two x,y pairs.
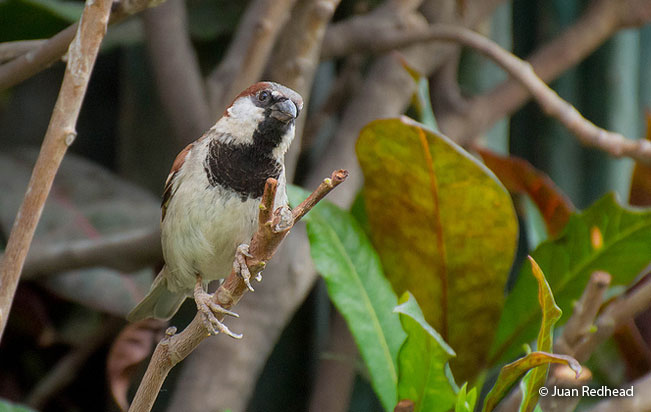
142,0 -> 211,147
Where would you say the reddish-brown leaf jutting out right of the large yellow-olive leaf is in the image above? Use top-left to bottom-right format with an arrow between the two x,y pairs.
479,149 -> 575,236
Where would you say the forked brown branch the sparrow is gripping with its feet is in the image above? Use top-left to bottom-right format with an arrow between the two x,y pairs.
129,170 -> 348,412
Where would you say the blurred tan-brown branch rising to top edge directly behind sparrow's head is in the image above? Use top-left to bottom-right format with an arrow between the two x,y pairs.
207,0 -> 296,116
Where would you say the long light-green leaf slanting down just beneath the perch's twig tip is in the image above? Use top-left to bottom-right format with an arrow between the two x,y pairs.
289,187 -> 405,411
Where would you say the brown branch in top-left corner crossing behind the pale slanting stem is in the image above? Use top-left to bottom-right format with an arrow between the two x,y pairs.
0,0 -> 162,90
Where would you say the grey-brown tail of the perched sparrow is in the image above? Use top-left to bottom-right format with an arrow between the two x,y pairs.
127,268 -> 187,322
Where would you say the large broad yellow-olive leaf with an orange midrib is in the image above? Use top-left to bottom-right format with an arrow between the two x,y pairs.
357,117 -> 517,381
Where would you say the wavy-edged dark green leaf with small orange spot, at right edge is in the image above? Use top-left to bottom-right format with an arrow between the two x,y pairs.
490,194 -> 651,364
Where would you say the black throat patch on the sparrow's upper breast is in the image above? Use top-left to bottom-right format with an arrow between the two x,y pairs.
204,140 -> 282,202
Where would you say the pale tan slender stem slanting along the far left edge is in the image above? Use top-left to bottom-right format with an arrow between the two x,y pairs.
0,0 -> 111,338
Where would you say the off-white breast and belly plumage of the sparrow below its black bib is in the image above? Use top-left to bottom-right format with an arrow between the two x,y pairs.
161,143 -> 260,290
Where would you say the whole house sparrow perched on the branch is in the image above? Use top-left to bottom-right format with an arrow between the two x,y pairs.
127,82 -> 303,337
